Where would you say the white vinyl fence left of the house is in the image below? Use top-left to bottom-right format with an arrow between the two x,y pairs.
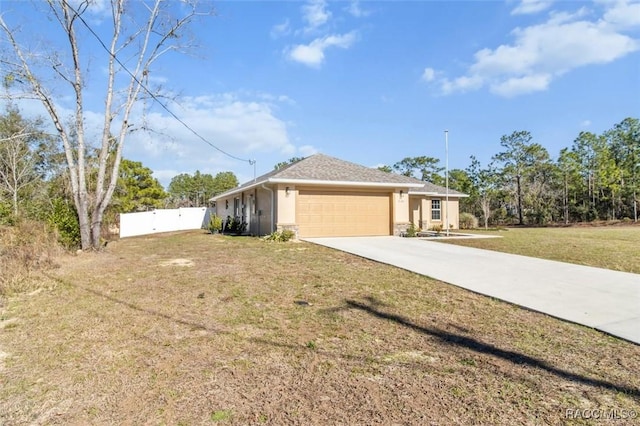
120,207 -> 211,238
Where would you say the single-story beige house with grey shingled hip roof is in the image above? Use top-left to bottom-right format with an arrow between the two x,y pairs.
211,154 -> 466,238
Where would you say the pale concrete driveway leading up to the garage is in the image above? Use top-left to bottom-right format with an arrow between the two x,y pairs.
305,237 -> 640,344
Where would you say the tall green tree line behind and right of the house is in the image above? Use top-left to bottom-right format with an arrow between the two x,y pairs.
379,117 -> 640,227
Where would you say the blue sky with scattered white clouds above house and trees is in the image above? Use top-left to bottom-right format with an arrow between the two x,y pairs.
0,0 -> 640,186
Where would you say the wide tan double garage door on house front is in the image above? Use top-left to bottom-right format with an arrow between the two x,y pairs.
296,190 -> 391,237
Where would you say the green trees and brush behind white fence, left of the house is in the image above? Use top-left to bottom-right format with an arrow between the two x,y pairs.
0,104 -> 238,248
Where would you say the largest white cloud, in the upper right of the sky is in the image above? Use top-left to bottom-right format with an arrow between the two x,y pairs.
423,2 -> 640,97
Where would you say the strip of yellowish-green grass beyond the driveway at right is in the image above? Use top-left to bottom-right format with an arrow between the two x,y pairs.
438,226 -> 640,274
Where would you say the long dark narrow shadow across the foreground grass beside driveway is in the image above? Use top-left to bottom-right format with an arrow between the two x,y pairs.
345,297 -> 640,398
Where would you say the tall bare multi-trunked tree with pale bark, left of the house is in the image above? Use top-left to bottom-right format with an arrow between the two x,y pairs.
0,0 -> 212,249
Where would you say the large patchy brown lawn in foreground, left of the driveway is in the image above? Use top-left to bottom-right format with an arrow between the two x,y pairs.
0,231 -> 640,425
